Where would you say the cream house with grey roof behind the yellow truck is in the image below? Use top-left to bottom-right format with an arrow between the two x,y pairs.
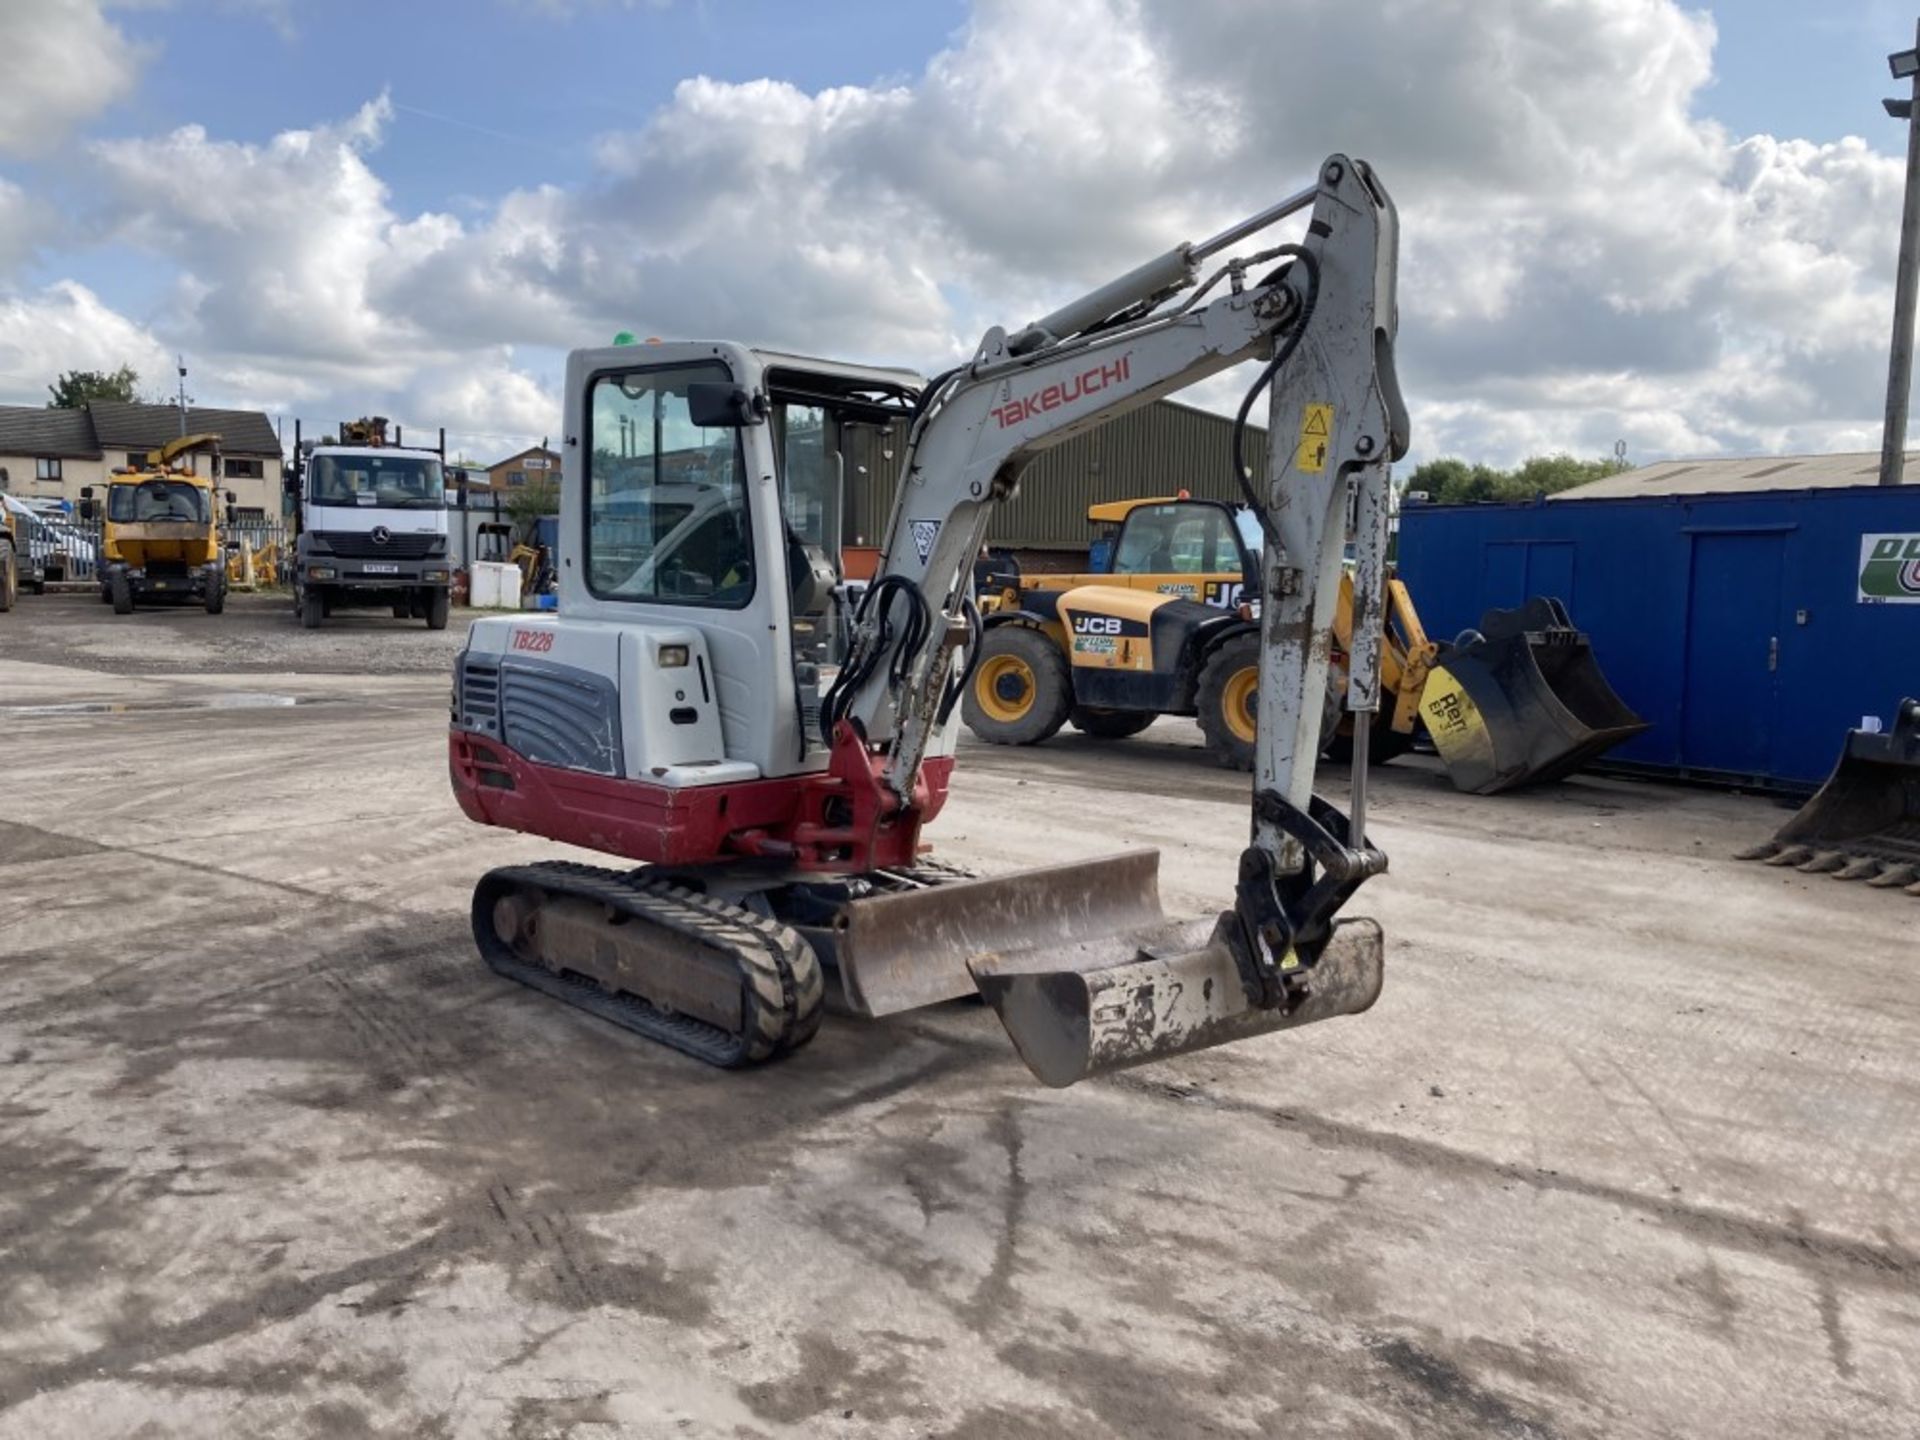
0,399 -> 280,520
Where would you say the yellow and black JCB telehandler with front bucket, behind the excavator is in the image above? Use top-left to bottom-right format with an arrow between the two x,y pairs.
962,493 -> 1645,795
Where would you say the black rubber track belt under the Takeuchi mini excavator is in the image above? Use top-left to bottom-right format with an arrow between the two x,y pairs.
472,860 -> 826,1069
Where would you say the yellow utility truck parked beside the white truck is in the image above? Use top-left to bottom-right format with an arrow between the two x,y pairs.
81,434 -> 232,614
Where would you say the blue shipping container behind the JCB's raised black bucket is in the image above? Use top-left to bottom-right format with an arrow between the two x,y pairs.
1400,486 -> 1920,789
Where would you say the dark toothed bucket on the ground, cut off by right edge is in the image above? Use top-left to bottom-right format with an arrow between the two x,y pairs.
1738,699 -> 1920,895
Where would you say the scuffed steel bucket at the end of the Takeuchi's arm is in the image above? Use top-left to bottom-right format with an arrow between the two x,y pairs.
972,912 -> 1384,1087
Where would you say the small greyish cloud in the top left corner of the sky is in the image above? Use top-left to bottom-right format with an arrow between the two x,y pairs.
0,0 -> 142,156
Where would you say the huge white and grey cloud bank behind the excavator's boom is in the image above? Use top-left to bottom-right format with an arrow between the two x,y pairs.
11,0 -> 1901,461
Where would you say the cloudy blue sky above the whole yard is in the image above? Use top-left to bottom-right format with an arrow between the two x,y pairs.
0,0 -> 1914,465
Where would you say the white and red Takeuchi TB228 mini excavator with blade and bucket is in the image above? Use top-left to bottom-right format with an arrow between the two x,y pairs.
449,156 -> 1407,1085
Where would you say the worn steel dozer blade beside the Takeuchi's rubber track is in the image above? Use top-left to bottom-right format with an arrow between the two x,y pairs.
814,851 -> 1165,1016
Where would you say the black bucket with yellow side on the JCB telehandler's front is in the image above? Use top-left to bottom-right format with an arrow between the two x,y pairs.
1421,595 -> 1647,795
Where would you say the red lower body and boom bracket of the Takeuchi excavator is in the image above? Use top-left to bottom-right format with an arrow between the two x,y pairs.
447,726 -> 954,872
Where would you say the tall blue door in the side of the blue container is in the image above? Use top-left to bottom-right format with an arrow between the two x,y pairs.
1680,534 -> 1786,776
